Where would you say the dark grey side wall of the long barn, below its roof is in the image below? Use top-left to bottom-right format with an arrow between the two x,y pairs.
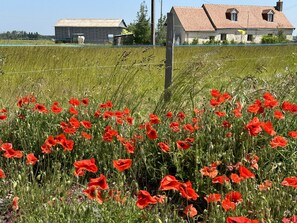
55,27 -> 123,44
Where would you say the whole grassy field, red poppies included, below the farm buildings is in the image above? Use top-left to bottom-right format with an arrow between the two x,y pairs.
0,45 -> 297,223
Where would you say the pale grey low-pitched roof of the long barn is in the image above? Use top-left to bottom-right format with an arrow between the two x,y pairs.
55,19 -> 127,28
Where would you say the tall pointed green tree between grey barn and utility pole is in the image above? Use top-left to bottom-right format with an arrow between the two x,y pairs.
128,2 -> 151,44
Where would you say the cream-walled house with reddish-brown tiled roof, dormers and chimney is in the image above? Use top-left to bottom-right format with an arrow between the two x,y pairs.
171,0 -> 295,44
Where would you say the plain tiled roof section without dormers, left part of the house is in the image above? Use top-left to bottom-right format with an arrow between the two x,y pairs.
172,7 -> 215,31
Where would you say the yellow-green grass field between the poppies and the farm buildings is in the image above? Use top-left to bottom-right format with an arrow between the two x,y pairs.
0,45 -> 297,110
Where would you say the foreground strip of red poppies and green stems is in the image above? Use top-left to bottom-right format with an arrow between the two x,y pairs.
0,70 -> 297,223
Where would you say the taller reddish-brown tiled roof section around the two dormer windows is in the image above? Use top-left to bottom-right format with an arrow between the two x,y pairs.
202,4 -> 294,29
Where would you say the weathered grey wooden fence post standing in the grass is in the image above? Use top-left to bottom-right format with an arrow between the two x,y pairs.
164,13 -> 174,102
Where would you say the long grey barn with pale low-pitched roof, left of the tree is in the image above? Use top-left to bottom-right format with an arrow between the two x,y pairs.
55,19 -> 127,44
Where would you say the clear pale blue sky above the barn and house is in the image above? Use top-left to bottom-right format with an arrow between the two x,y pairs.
0,0 -> 297,35
